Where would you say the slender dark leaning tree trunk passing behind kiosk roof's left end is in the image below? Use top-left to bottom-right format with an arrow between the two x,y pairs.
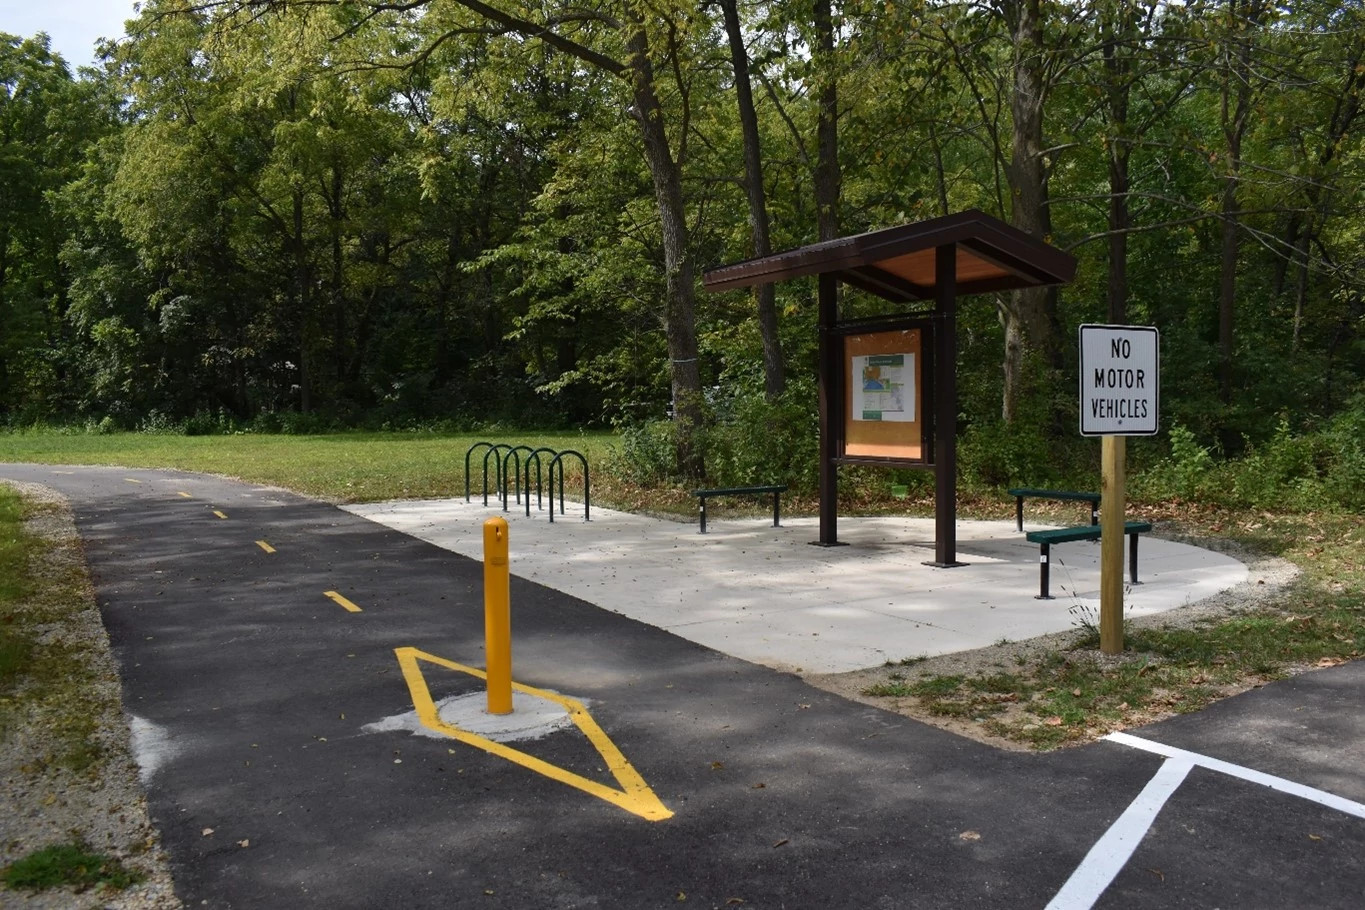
721,0 -> 786,401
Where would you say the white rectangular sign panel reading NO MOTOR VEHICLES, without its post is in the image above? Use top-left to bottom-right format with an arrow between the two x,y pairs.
1081,325 -> 1160,437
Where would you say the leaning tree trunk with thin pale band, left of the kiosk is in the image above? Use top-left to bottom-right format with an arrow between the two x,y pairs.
627,11 -> 706,478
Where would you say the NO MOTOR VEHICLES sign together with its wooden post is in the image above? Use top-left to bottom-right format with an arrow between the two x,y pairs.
1080,325 -> 1160,654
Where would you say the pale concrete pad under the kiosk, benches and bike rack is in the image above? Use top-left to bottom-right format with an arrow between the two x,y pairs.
345,499 -> 1248,673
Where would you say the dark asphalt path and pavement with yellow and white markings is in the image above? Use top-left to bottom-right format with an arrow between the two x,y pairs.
0,465 -> 1365,907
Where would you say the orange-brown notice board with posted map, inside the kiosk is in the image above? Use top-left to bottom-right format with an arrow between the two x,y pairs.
842,327 -> 924,464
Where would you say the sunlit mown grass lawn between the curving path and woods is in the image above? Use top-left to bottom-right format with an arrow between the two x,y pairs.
0,431 -> 616,502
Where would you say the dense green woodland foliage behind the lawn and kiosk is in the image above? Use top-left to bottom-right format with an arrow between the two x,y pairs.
0,0 -> 1365,482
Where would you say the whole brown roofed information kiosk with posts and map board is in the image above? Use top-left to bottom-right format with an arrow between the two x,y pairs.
703,210 -> 1076,568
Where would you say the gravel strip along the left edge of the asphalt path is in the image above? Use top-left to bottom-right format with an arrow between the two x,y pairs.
0,480 -> 182,910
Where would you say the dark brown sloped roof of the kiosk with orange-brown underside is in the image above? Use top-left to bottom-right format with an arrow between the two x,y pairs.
702,209 -> 1076,303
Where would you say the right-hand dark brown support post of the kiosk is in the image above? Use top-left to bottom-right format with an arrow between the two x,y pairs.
930,243 -> 962,569
